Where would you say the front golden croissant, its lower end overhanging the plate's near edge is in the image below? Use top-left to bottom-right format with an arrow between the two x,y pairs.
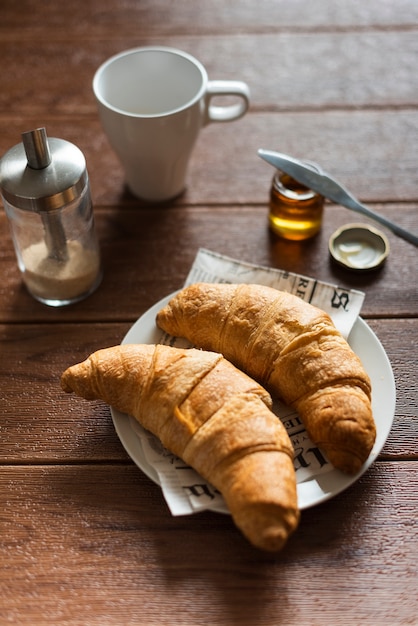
61,344 -> 299,551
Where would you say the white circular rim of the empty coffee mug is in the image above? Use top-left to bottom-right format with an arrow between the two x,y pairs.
92,46 -> 208,119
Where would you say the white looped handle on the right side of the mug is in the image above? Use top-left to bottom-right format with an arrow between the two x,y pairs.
204,80 -> 250,126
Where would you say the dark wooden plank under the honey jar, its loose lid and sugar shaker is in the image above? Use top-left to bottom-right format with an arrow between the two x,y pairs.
0,205 -> 418,322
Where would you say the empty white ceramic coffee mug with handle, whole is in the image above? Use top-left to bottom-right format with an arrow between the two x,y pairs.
93,47 -> 250,202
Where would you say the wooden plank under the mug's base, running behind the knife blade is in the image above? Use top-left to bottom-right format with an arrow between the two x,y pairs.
0,111 -> 418,208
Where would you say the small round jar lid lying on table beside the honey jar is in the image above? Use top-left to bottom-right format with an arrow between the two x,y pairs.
329,224 -> 389,271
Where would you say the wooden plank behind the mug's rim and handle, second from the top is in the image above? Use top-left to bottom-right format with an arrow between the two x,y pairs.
0,27 -> 418,116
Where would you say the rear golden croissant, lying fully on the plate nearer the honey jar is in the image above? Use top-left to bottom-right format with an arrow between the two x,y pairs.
156,283 -> 376,473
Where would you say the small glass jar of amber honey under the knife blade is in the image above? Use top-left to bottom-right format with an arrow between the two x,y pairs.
269,165 -> 324,241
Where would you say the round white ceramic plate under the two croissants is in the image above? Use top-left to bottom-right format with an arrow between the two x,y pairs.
111,294 -> 396,512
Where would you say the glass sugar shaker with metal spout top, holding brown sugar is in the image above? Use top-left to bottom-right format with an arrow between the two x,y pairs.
0,128 -> 102,307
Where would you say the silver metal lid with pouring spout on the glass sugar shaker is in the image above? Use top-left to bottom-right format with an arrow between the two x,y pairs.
0,128 -> 88,211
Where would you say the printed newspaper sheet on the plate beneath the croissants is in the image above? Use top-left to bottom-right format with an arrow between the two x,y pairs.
136,249 -> 364,515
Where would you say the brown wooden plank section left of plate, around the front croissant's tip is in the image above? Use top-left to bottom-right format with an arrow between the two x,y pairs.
0,323 -> 128,463
